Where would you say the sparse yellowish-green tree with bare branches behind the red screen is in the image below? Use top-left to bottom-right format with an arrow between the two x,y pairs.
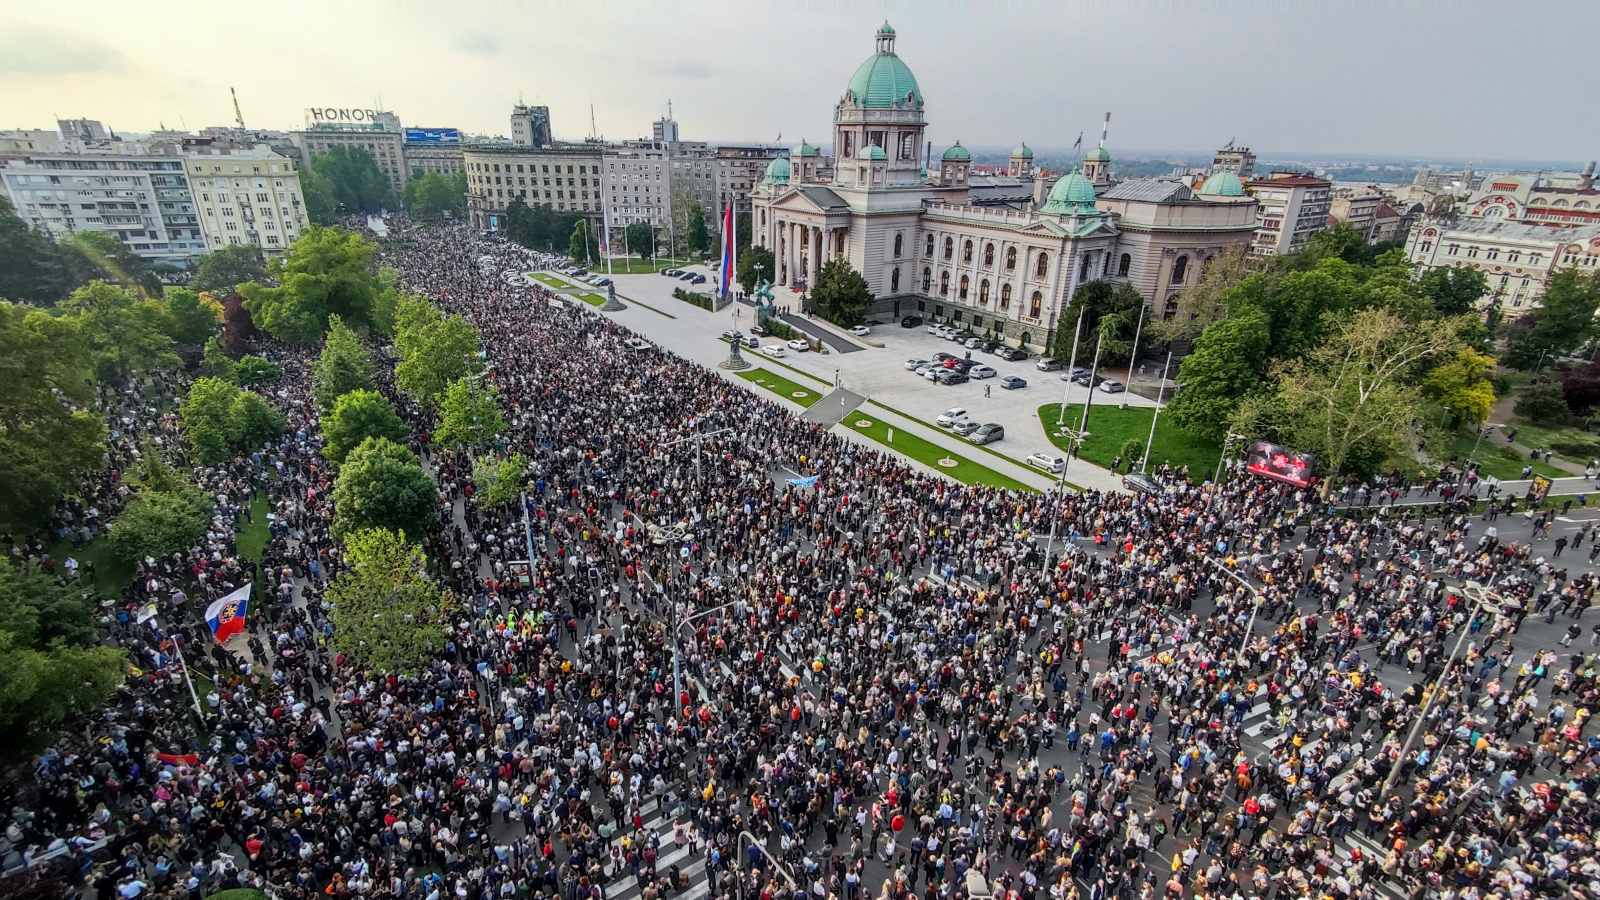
1267,309 -> 1461,474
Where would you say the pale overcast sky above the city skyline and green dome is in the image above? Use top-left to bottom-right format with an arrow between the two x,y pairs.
0,0 -> 1600,160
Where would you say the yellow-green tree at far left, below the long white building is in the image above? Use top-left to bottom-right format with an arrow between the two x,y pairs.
61,282 -> 182,384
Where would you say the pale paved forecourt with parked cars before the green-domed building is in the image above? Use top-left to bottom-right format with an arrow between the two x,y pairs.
588,266 -> 1154,487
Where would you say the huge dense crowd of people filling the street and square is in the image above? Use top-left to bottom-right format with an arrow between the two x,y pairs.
5,219 -> 1600,900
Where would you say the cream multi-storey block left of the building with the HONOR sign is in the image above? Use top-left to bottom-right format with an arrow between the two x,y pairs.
184,139 -> 310,255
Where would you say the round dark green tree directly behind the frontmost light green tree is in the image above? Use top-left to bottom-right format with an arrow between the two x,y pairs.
333,437 -> 438,536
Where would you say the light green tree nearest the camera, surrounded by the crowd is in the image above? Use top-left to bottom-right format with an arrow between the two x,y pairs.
328,528 -> 453,674
